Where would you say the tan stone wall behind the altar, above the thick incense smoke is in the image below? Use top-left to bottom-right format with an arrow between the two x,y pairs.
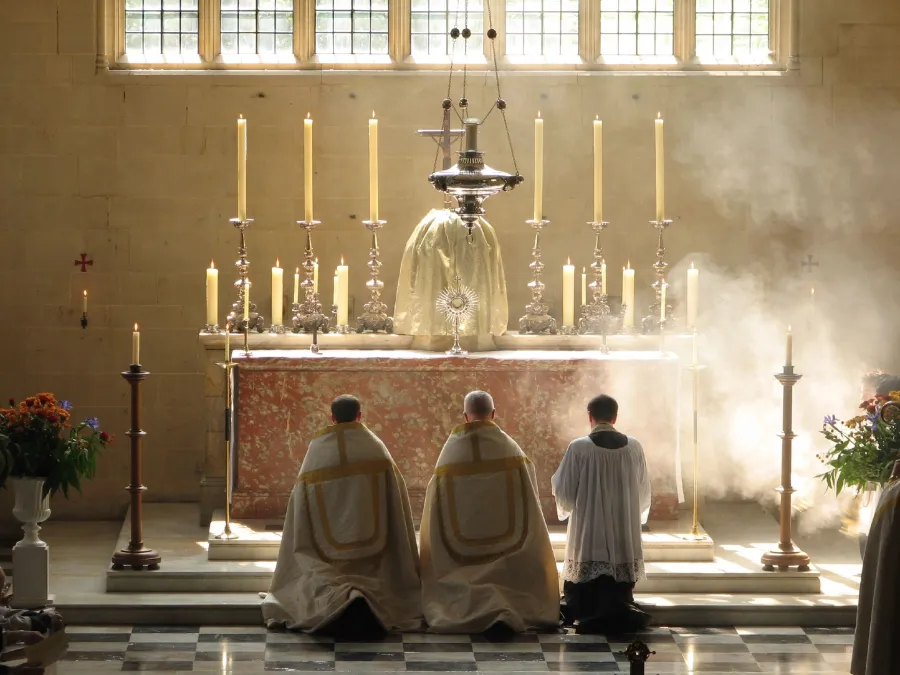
0,0 -> 900,528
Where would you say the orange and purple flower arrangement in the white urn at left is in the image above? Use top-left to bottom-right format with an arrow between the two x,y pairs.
0,394 -> 113,497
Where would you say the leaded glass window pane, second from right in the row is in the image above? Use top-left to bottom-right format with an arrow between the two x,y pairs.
600,0 -> 672,56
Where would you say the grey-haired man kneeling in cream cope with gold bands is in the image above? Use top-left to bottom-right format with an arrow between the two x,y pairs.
421,391 -> 559,633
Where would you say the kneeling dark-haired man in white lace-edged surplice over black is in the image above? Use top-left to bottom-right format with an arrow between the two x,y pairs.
552,396 -> 650,634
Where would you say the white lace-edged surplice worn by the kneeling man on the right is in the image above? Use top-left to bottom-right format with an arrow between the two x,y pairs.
553,426 -> 650,583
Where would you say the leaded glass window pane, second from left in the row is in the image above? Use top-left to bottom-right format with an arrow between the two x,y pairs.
220,0 -> 294,55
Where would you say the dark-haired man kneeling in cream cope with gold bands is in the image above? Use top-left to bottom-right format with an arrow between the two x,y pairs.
262,396 -> 422,636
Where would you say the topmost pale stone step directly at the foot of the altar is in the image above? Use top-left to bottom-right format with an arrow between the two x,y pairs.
207,510 -> 715,563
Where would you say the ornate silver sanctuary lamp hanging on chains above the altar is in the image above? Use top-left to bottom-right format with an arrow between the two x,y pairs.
428,3 -> 524,242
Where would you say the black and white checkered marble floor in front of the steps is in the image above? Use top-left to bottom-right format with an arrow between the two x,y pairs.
57,626 -> 853,675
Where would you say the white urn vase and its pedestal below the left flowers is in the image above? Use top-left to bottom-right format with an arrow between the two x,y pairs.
9,477 -> 51,608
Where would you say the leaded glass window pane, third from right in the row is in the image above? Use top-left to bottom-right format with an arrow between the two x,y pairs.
506,0 -> 578,56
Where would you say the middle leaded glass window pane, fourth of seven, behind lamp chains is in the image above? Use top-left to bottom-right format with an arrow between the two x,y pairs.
410,0 -> 484,57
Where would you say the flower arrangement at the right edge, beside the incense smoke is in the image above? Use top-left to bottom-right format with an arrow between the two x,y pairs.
819,391 -> 900,494
